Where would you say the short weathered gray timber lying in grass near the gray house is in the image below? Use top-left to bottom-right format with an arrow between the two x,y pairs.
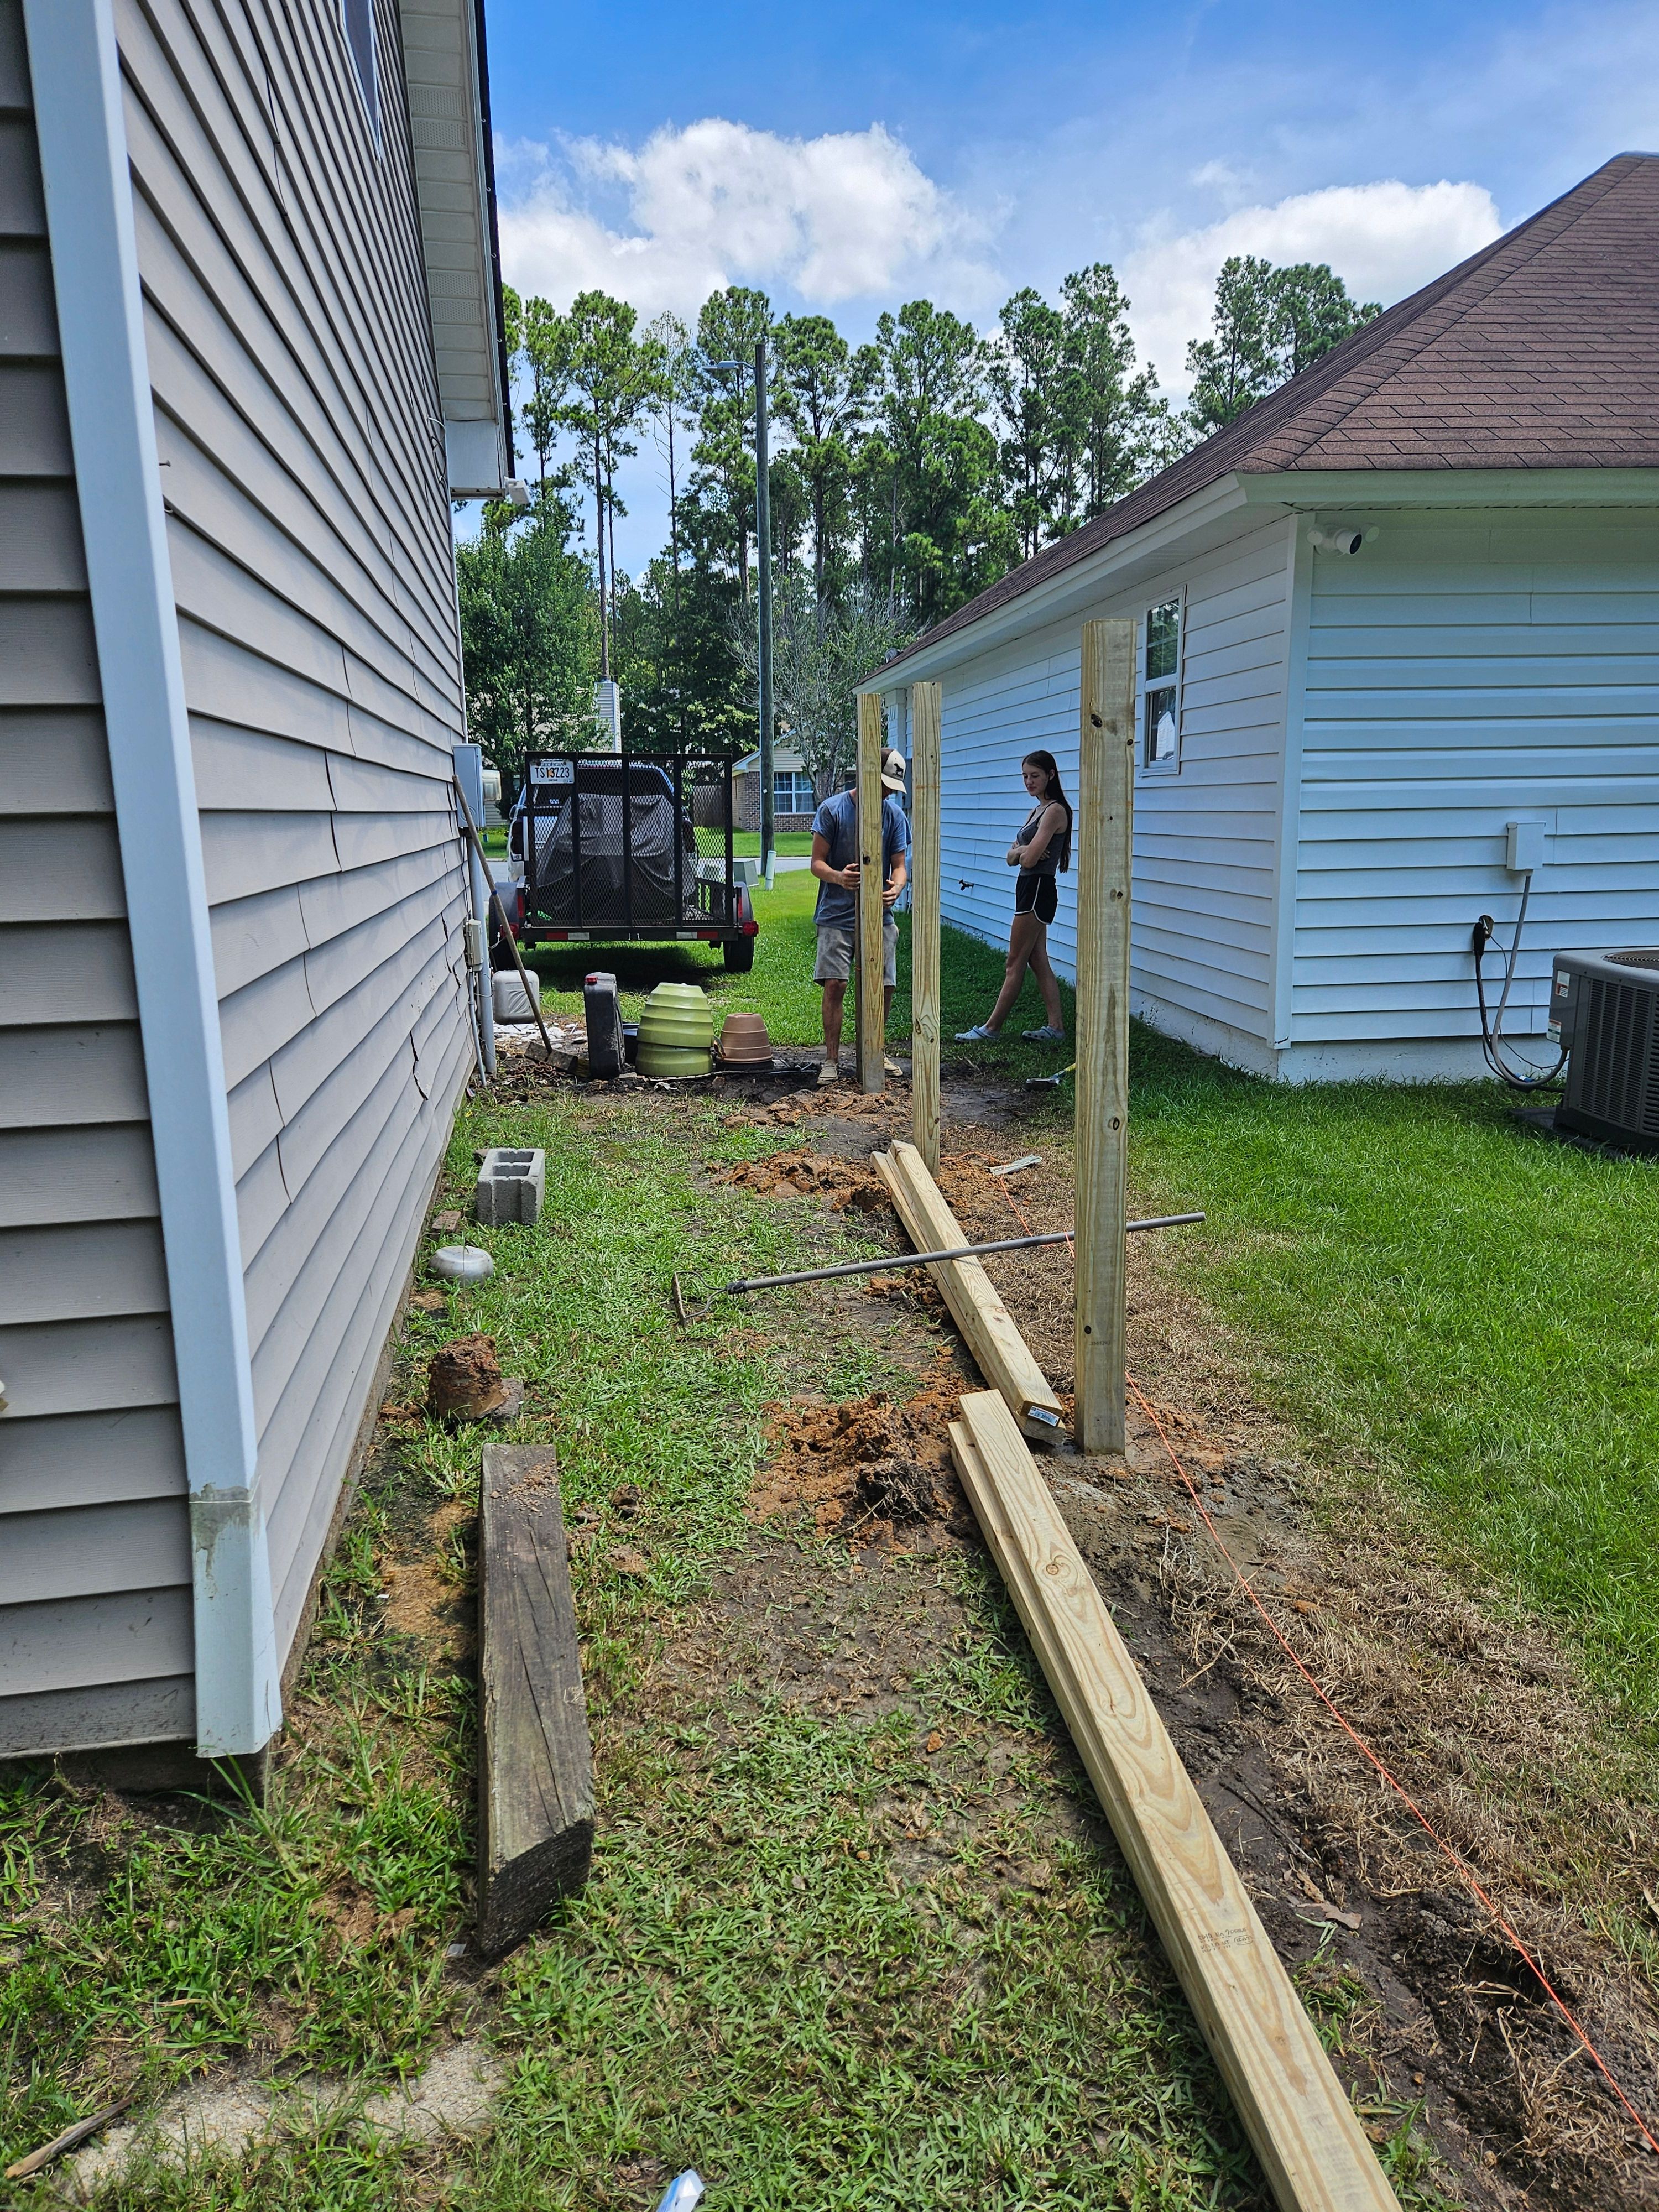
478,1444 -> 593,1958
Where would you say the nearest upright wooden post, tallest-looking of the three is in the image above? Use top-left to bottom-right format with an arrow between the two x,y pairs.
1075,622 -> 1135,1451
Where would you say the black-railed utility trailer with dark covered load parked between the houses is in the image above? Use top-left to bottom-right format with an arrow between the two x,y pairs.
487,750 -> 759,973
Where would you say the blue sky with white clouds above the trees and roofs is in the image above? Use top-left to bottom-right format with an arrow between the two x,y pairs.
473,0 -> 1659,566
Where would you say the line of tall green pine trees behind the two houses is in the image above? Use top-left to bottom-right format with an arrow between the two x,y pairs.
458,257 -> 1380,792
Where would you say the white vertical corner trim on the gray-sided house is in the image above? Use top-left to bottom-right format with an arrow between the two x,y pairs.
24,0 -> 281,1756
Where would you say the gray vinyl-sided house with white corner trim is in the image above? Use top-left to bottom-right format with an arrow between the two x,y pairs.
0,0 -> 507,1761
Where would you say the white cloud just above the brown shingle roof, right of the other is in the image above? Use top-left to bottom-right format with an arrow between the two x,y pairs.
1121,179 -> 1502,394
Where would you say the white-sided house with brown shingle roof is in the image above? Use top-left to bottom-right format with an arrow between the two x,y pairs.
863,155 -> 1659,1079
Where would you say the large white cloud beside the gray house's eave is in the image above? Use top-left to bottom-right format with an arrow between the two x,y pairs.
487,117 -> 995,314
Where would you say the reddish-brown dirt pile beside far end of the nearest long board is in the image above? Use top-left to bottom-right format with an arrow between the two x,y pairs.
750,1385 -> 967,1544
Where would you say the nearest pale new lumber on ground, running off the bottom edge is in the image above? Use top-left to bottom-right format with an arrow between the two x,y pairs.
951,1391 -> 1398,2212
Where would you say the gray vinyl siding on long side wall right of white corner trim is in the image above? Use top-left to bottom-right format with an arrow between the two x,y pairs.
117,0 -> 471,1650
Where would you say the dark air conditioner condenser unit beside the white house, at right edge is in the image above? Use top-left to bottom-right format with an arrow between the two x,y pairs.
1551,945 -> 1659,1152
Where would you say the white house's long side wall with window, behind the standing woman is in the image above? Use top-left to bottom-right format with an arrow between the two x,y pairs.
940,520 -> 1292,1064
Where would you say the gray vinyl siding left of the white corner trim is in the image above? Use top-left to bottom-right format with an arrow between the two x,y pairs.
0,0 -> 195,1756
